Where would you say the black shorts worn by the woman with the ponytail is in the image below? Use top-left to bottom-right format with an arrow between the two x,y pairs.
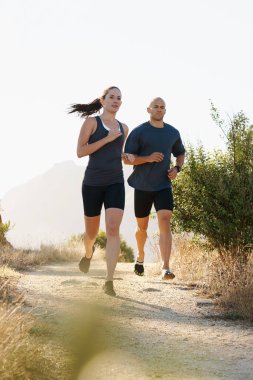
82,183 -> 125,216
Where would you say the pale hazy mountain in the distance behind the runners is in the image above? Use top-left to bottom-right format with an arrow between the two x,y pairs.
1,161 -> 155,259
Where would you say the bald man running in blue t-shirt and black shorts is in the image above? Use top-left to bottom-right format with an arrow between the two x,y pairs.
123,97 -> 185,280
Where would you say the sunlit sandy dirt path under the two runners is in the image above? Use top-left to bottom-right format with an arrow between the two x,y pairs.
20,257 -> 253,380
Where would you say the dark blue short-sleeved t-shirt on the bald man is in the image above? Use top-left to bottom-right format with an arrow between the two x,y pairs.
125,122 -> 185,191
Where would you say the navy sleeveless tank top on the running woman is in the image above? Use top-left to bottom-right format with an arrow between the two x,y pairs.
84,116 -> 124,186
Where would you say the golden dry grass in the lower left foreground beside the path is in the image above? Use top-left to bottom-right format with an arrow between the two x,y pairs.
0,274 -> 71,380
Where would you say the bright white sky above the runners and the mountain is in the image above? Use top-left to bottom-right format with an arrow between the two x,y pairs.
0,0 -> 253,199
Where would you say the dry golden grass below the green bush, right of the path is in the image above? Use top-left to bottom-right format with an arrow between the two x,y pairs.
150,235 -> 253,321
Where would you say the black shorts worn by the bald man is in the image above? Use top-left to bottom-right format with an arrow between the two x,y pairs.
134,188 -> 173,218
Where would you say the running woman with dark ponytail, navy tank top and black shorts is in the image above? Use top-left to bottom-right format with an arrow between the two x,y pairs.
69,86 -> 128,296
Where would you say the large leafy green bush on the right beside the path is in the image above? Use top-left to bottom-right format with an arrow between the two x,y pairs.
173,105 -> 253,261
